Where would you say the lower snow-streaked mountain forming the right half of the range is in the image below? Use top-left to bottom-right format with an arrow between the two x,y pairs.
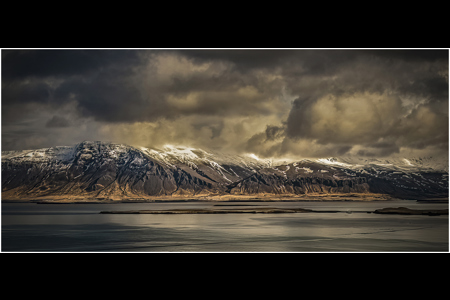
230,158 -> 448,199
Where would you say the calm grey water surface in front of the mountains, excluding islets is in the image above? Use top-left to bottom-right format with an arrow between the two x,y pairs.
1,201 -> 449,252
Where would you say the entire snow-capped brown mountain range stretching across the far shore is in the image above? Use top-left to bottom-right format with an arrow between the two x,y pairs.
2,142 -> 448,199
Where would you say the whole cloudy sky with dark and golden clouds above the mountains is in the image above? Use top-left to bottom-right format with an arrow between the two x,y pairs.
1,49 -> 449,158
